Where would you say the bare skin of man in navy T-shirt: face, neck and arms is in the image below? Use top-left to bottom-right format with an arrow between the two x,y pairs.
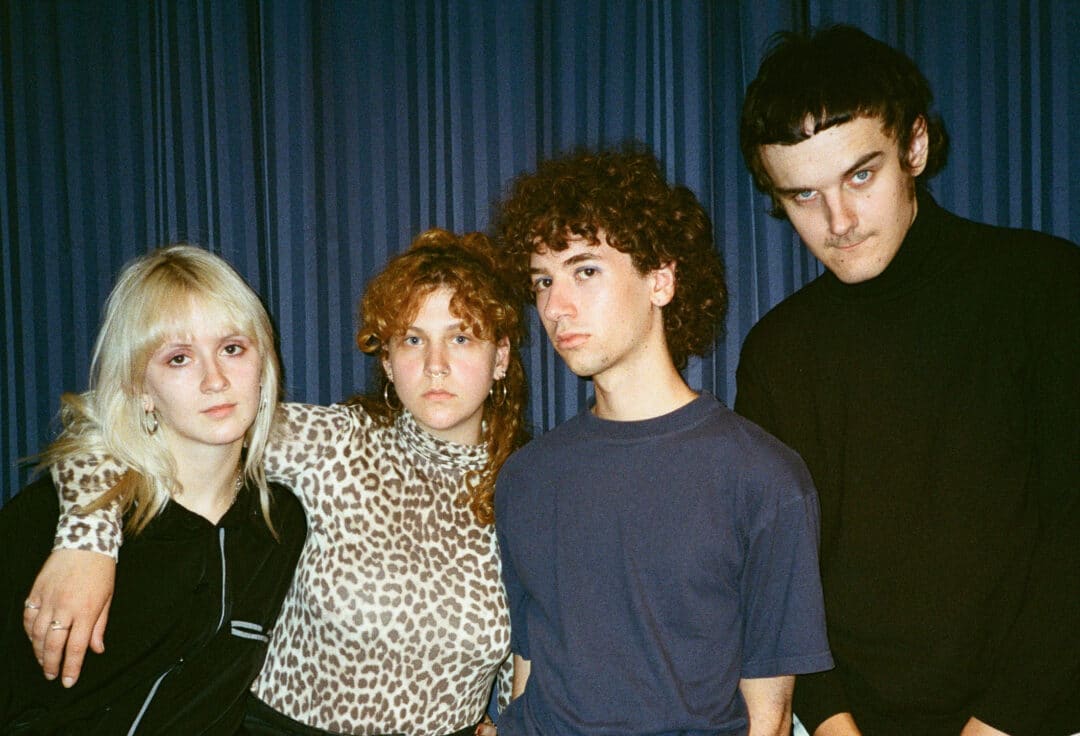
522,231 -> 794,736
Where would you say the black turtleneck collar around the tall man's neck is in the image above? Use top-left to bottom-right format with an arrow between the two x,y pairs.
822,187 -> 949,302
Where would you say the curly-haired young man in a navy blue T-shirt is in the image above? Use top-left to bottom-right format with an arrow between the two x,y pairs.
496,148 -> 832,736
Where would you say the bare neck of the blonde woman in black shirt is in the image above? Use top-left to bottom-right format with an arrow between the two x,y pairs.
173,442 -> 242,524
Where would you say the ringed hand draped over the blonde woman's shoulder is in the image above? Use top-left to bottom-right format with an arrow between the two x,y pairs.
23,549 -> 117,687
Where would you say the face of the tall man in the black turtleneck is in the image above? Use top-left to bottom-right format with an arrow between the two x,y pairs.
761,118 -> 928,283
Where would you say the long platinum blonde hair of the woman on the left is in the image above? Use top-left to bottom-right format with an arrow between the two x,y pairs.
42,244 -> 281,534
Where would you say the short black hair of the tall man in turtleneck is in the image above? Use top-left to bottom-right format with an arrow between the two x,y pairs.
739,25 -> 948,218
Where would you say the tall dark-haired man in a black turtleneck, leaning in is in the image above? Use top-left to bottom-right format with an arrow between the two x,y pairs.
735,22 -> 1080,736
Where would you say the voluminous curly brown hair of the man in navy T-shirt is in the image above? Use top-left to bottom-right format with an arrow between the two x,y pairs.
494,143 -> 728,370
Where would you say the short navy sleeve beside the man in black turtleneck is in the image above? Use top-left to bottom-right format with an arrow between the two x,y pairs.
740,451 -> 833,678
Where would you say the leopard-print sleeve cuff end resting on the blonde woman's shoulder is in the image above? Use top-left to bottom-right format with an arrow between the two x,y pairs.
50,455 -> 125,560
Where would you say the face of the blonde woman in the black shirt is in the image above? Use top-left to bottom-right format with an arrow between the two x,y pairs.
143,304 -> 262,461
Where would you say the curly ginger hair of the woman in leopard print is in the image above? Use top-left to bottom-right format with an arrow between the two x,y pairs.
349,228 -> 528,524
